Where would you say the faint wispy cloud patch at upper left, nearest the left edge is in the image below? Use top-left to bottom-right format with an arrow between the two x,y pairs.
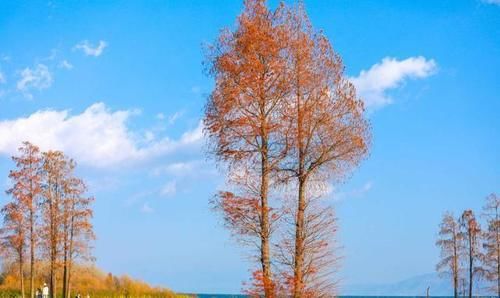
16,64 -> 54,97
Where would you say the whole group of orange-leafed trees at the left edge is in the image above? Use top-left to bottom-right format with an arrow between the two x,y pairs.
0,142 -> 95,298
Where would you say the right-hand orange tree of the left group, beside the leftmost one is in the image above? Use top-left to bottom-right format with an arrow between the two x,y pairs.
42,151 -> 94,298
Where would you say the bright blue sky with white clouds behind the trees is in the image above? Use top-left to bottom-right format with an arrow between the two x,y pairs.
0,0 -> 500,292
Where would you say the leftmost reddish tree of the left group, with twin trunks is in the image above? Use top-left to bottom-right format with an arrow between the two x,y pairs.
3,142 -> 42,297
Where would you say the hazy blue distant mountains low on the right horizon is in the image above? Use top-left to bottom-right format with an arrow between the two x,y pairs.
340,273 -> 489,296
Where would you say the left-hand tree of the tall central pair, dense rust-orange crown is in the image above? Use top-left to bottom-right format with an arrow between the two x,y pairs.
204,0 -> 288,297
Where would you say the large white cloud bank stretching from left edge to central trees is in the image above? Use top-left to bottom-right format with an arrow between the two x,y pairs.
0,103 -> 203,167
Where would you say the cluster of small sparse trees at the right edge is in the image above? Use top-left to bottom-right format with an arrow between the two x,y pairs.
436,193 -> 500,297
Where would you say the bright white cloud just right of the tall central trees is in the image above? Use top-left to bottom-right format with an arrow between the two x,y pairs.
350,56 -> 437,109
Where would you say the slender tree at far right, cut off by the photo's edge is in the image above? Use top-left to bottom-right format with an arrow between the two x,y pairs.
483,193 -> 500,297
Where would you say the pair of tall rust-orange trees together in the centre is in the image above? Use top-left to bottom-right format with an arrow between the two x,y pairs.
204,0 -> 370,298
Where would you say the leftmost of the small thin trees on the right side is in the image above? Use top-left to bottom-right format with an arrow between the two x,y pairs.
436,213 -> 464,298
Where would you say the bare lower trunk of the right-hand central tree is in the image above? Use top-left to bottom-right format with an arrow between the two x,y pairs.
293,177 -> 306,298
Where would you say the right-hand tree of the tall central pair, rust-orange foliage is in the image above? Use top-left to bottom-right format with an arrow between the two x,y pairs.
281,5 -> 369,298
